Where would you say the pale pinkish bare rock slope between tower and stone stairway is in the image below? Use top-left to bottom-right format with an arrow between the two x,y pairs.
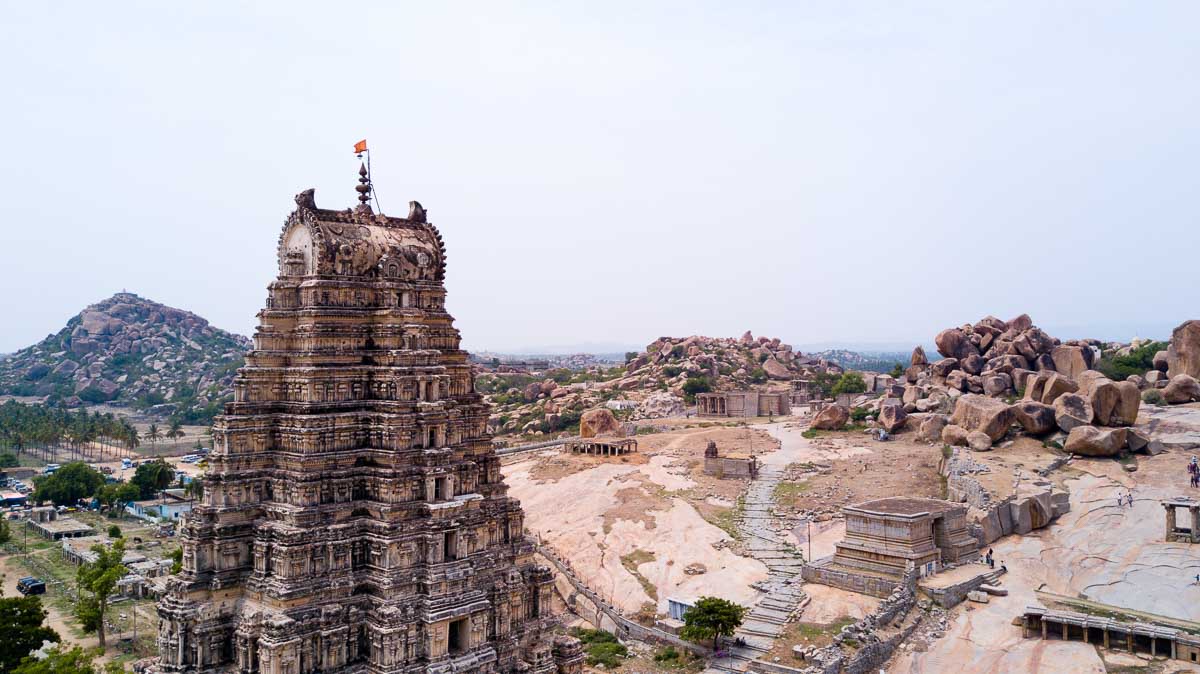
504,427 -> 776,613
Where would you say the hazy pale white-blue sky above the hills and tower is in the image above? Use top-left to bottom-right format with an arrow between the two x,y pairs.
0,1 -> 1200,351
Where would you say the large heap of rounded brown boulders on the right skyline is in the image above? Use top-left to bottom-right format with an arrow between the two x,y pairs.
863,314 -> 1161,456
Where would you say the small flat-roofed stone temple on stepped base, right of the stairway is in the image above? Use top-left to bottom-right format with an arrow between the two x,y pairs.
803,497 -> 979,596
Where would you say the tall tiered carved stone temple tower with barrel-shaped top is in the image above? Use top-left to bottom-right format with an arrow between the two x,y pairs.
156,170 -> 582,674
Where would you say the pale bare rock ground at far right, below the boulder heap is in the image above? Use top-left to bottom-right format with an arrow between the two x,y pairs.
888,402 -> 1200,674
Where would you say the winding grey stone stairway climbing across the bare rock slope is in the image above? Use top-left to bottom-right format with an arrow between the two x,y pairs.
704,467 -> 805,674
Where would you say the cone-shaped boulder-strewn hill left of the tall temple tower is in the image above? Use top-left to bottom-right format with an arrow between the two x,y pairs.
0,293 -> 251,422
